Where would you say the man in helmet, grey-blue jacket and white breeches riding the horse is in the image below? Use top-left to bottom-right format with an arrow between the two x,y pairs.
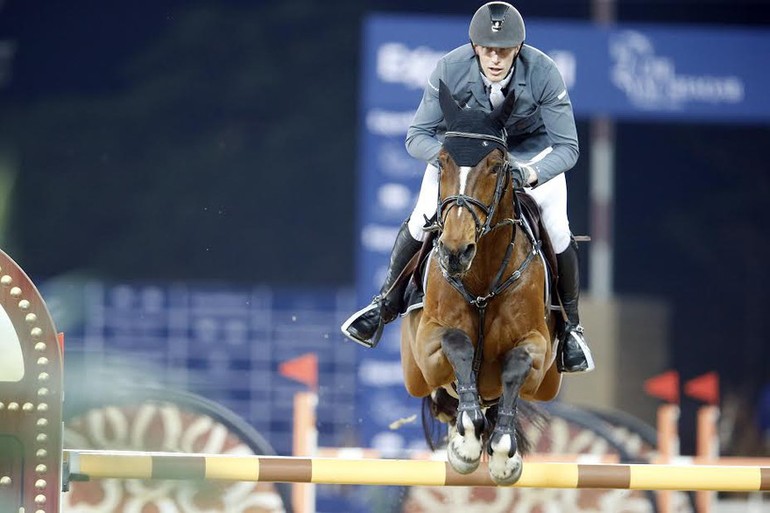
342,2 -> 594,372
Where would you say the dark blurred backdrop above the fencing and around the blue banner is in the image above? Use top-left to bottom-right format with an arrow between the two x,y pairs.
0,0 -> 770,454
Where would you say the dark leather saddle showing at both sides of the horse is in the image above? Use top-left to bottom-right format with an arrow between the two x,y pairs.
398,191 -> 560,315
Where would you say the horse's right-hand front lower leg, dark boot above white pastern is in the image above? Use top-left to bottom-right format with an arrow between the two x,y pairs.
487,346 -> 532,485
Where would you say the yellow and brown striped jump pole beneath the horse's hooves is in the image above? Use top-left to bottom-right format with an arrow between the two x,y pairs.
64,451 -> 770,492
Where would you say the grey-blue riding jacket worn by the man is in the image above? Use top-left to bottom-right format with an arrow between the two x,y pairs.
406,43 -> 579,184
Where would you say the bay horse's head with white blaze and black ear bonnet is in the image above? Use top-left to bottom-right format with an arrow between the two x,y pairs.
437,82 -> 514,276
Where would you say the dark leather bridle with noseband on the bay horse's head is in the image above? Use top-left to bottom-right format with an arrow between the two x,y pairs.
436,130 -> 519,238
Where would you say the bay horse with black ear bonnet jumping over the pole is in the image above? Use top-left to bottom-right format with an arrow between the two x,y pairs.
401,82 -> 561,485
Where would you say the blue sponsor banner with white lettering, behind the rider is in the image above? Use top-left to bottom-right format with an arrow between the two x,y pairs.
356,15 -> 770,450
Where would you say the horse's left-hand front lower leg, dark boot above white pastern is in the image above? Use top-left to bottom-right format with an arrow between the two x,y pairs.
441,329 -> 485,474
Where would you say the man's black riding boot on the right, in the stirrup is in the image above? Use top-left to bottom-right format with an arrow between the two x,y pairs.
556,239 -> 594,372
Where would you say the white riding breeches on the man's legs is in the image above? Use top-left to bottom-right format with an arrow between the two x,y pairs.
408,164 -> 571,254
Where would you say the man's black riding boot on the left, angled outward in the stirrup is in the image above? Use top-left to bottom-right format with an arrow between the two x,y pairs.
342,221 -> 422,347
